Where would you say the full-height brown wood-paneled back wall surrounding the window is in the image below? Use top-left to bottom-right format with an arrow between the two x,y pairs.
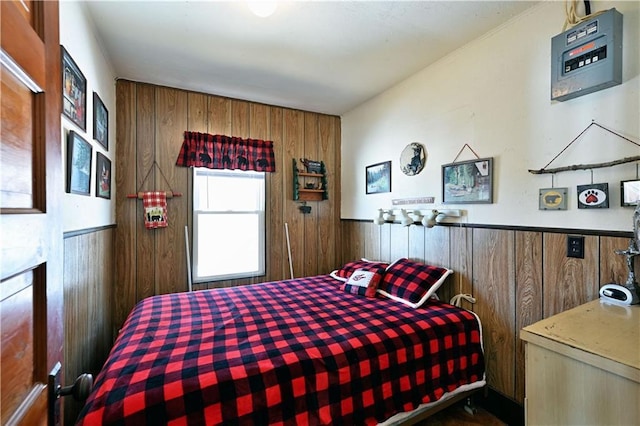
114,80 -> 340,327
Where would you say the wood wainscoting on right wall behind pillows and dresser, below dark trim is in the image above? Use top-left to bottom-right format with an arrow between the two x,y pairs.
341,220 -> 640,404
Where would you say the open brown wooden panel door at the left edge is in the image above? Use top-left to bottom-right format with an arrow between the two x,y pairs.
0,0 -> 64,425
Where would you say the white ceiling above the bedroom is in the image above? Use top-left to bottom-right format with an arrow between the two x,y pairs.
82,0 -> 537,115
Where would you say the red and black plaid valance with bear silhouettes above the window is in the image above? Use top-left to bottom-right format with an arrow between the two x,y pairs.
176,132 -> 276,172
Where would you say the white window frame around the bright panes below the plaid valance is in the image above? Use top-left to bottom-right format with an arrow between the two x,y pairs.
192,167 -> 266,283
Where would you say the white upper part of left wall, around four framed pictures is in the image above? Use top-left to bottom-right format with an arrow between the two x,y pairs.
60,1 -> 116,232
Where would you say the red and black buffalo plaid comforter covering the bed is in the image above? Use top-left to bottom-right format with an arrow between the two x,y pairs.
79,275 -> 484,425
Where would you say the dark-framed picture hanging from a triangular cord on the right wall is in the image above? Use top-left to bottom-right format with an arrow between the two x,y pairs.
442,157 -> 493,204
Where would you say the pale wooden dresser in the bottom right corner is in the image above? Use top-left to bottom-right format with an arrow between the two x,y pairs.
520,300 -> 640,426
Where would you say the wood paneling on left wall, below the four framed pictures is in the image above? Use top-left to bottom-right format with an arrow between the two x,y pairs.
64,227 -> 115,425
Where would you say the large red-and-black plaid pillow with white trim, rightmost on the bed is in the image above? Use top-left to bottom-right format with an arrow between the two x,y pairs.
378,258 -> 453,308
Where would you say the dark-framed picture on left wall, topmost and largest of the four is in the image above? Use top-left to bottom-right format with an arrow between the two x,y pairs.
60,46 -> 87,130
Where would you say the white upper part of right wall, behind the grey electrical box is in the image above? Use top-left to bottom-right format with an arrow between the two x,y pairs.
341,1 -> 640,231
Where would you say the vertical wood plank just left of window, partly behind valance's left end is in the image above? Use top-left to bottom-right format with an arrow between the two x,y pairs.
151,88 -> 190,294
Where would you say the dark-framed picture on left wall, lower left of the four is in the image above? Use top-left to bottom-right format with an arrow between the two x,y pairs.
67,130 -> 93,195
